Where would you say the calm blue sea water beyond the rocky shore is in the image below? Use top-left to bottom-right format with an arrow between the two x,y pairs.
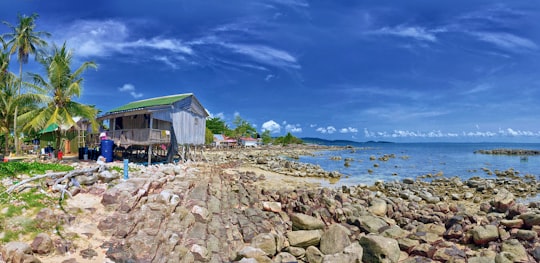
299,143 -> 540,186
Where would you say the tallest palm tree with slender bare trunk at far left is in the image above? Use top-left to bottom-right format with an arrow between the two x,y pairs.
4,14 -> 50,154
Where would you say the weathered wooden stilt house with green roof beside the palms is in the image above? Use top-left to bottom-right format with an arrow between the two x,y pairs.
88,93 -> 208,162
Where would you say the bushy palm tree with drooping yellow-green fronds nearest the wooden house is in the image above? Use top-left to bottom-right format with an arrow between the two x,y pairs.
20,43 -> 98,154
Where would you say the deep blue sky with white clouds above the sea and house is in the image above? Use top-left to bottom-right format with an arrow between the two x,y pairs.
0,0 -> 540,142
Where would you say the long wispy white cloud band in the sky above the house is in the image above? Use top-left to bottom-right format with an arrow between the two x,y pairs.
53,19 -> 301,70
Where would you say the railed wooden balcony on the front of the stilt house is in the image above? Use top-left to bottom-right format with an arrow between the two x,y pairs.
86,129 -> 171,148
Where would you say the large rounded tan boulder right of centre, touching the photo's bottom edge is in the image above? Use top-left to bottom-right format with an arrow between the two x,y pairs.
359,235 -> 400,263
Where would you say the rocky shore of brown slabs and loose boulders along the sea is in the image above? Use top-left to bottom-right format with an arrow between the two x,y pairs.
1,146 -> 540,262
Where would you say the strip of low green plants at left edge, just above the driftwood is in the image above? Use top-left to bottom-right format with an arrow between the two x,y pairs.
0,162 -> 73,178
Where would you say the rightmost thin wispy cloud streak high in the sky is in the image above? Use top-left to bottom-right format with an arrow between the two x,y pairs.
471,32 -> 538,51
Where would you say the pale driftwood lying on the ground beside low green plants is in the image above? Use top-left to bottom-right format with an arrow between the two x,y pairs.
4,165 -> 104,198
